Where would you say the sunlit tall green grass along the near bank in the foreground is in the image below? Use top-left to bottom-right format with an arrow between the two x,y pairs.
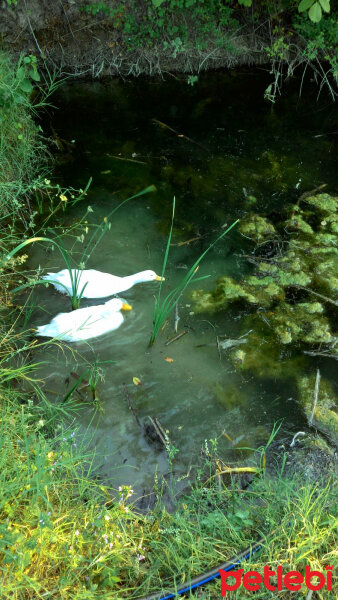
0,386 -> 337,600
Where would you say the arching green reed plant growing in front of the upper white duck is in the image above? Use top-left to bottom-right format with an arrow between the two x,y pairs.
5,185 -> 156,310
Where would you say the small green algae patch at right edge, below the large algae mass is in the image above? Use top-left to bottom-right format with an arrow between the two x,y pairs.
297,375 -> 338,440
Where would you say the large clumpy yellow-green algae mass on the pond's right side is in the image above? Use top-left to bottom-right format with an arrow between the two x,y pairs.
192,194 -> 338,378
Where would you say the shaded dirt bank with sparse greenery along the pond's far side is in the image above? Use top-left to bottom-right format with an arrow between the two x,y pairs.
0,0 -> 288,77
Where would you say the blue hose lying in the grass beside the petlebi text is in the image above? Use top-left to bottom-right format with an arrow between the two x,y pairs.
139,539 -> 264,600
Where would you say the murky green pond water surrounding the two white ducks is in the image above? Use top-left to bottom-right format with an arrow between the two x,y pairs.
30,71 -> 335,494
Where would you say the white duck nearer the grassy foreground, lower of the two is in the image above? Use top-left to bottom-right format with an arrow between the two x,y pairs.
37,298 -> 132,342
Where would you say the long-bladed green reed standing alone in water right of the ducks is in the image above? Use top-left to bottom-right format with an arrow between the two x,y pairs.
149,198 -> 239,346
